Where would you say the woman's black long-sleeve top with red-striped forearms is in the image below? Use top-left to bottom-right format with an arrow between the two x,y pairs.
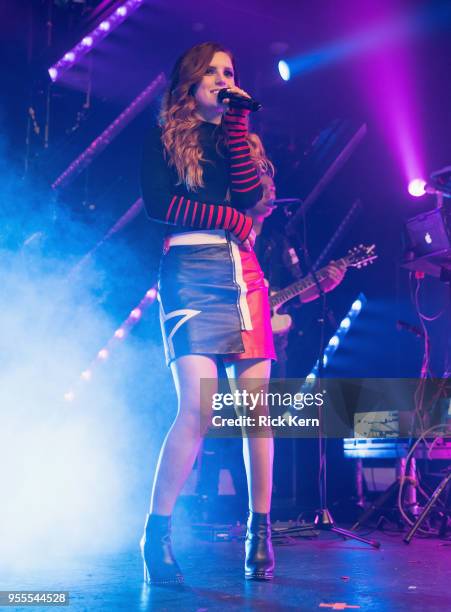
141,110 -> 262,241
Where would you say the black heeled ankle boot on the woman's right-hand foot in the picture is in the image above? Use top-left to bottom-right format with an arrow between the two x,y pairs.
244,512 -> 274,580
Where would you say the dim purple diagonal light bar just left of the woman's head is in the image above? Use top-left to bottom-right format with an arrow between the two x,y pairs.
52,72 -> 166,189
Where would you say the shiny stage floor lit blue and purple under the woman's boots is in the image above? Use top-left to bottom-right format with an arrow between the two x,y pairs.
1,532 -> 451,612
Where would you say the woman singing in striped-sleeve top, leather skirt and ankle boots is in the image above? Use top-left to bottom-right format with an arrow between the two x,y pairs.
141,42 -> 275,584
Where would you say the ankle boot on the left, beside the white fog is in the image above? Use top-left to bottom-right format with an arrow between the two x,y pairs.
141,514 -> 183,584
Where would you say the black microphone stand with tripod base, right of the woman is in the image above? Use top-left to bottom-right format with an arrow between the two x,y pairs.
287,217 -> 381,548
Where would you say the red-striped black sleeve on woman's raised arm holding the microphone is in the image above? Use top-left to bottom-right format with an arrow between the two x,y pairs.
223,108 -> 263,209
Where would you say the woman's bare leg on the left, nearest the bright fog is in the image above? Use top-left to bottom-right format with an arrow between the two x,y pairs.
150,355 -> 218,516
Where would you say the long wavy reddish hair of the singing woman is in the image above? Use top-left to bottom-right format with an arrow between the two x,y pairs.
159,42 -> 270,191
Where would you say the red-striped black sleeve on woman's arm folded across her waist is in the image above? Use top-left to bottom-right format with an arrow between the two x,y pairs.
141,130 -> 252,242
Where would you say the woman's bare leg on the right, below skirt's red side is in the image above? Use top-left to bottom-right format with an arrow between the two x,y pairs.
227,359 -> 274,514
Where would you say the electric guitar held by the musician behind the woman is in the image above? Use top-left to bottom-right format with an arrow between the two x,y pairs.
269,244 -> 377,334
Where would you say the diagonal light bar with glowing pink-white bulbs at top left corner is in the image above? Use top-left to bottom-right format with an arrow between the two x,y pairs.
48,0 -> 143,82
